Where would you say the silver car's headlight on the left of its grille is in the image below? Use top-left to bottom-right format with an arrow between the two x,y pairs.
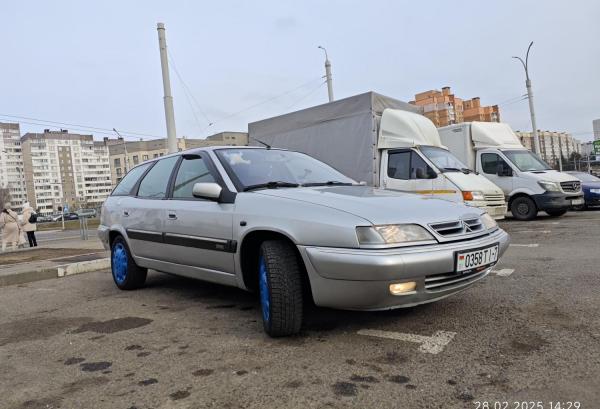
356,224 -> 434,245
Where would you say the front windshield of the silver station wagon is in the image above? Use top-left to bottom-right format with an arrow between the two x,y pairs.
216,148 -> 356,190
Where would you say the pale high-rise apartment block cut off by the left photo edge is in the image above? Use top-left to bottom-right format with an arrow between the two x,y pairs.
0,122 -> 27,211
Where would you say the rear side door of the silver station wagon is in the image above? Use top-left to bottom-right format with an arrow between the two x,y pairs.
124,156 -> 180,260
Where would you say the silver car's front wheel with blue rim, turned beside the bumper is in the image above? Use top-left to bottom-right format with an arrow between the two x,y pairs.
258,240 -> 303,337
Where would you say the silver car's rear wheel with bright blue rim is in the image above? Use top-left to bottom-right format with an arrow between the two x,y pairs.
110,236 -> 148,290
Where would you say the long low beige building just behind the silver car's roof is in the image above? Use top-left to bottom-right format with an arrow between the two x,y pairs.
105,132 -> 248,185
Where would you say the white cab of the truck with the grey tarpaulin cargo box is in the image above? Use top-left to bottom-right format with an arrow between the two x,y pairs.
377,109 -> 507,219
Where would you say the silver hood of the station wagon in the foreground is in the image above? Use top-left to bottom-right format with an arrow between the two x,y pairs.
254,186 -> 483,225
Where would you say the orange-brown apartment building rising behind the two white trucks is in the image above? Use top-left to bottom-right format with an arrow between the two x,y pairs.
410,87 -> 500,127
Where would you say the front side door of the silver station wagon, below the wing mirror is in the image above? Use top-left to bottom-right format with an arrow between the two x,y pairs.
164,153 -> 236,274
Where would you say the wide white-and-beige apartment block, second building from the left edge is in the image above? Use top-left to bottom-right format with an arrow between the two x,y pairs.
21,129 -> 112,214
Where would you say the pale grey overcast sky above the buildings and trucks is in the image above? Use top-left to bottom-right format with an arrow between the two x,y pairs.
0,0 -> 600,140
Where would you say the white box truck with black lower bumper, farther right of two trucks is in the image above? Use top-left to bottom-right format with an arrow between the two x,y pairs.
438,122 -> 584,220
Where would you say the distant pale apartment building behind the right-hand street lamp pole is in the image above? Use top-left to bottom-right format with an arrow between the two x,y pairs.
515,130 -> 581,168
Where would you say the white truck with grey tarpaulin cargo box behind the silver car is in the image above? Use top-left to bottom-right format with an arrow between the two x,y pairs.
248,92 -> 506,219
